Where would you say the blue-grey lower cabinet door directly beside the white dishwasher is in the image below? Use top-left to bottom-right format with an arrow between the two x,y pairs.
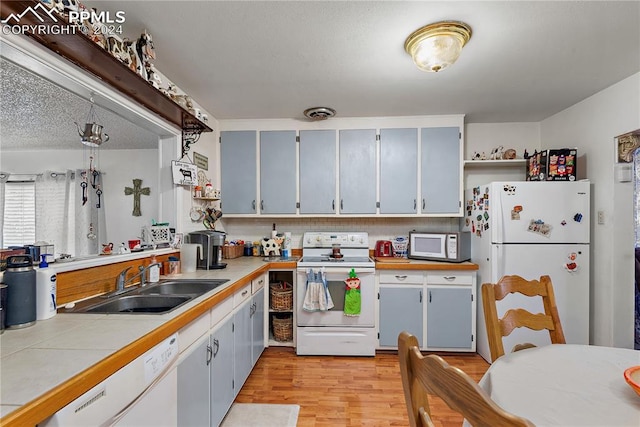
178,334 -> 211,427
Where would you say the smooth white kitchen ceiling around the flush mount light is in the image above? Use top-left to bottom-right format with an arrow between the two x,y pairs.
85,0 -> 640,123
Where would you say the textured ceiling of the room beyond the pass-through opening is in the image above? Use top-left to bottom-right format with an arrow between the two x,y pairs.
0,60 -> 158,150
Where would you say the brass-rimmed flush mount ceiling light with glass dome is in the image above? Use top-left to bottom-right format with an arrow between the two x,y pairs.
404,21 -> 471,73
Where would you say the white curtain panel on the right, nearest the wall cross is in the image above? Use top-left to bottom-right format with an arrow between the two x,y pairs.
73,169 -> 107,256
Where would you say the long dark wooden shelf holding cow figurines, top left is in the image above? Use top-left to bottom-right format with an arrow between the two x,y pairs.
0,0 -> 213,134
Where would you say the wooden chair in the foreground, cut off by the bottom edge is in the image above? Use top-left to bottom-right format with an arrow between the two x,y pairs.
398,332 -> 533,427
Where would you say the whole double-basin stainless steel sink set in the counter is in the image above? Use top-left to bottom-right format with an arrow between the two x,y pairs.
62,279 -> 229,314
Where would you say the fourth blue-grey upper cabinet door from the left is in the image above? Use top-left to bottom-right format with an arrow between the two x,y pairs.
340,129 -> 376,214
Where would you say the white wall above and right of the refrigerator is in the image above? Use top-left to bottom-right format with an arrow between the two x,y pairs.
540,73 -> 640,348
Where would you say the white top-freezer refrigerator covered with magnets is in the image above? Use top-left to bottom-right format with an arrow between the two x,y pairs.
462,181 -> 590,362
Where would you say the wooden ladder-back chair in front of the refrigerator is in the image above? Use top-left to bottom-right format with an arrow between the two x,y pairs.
482,276 -> 566,360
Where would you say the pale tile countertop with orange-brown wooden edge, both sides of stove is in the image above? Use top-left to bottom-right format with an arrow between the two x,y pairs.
0,257 -> 478,426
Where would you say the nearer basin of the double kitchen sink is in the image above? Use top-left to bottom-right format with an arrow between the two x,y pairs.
82,295 -> 193,314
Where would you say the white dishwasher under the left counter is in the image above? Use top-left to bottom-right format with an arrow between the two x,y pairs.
39,334 -> 179,427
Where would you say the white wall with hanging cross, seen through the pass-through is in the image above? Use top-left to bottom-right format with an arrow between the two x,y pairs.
0,148 -> 159,251
